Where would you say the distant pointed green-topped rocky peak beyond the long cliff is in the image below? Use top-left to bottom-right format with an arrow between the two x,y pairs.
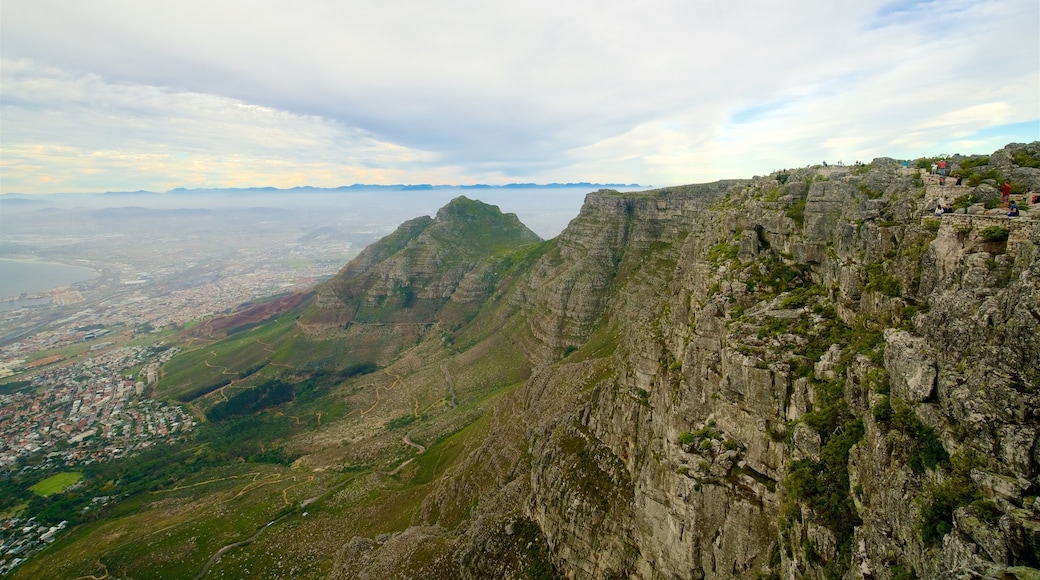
302,197 -> 541,363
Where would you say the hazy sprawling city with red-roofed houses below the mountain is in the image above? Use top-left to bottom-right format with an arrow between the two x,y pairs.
0,193 -> 378,575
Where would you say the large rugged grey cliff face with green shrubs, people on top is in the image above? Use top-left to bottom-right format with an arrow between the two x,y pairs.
328,143 -> 1040,579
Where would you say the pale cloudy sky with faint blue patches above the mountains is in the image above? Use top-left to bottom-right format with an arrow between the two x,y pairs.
0,0 -> 1040,193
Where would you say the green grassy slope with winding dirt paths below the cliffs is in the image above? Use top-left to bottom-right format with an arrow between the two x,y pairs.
15,242 -> 529,578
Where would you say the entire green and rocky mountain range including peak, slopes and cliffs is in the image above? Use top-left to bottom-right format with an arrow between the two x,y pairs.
18,143 -> 1040,579
